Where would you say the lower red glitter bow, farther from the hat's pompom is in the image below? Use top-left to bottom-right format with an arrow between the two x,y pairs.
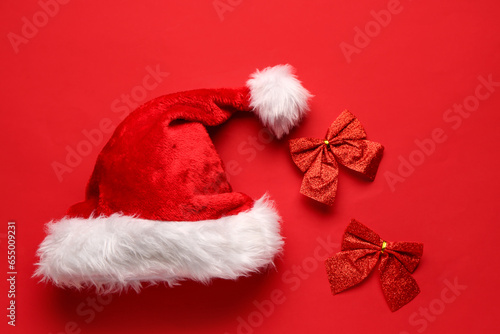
326,219 -> 424,312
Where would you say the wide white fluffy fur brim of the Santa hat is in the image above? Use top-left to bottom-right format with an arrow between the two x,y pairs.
35,195 -> 283,292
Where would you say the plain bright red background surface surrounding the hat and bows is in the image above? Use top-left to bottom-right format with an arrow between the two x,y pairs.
0,0 -> 500,334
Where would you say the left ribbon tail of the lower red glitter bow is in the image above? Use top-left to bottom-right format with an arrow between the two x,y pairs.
325,249 -> 379,295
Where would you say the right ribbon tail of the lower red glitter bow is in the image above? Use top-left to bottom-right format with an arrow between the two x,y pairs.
379,254 -> 420,312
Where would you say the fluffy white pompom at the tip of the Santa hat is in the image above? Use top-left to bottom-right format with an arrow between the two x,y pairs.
247,64 -> 312,139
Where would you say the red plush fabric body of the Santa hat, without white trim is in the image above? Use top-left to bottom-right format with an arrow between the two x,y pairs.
68,87 -> 254,221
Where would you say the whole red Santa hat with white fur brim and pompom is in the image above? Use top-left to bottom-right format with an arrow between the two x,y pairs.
35,65 -> 310,291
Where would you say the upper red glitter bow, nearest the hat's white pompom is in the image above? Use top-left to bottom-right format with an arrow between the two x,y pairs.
290,110 -> 384,205
